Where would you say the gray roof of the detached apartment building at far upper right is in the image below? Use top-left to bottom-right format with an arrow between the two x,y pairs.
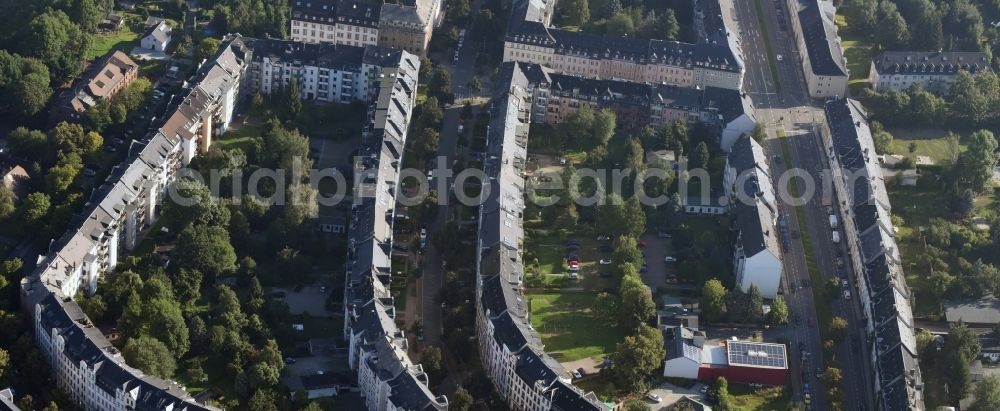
872,51 -> 990,75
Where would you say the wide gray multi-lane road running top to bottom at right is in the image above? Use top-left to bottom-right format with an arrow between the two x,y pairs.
734,0 -> 873,409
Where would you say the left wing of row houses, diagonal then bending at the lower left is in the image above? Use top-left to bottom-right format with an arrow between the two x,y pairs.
20,36 -> 249,410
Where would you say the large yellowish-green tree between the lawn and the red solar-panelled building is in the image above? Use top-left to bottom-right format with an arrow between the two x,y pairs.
613,324 -> 664,392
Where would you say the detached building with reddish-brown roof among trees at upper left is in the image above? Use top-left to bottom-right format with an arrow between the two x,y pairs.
49,51 -> 139,123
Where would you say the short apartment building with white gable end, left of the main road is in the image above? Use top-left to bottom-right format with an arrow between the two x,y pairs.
723,137 -> 783,298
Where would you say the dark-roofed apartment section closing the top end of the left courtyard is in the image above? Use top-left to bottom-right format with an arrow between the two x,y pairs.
248,39 -> 402,103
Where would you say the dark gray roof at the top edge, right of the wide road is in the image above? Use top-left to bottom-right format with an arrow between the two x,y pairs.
799,0 -> 847,76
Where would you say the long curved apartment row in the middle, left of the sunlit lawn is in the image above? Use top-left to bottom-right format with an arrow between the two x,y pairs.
476,62 -> 608,411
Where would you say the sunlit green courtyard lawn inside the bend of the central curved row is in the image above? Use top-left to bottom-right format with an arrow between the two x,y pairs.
526,293 -> 619,362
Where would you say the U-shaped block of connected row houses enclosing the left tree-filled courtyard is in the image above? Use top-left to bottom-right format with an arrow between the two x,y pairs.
14,35 -> 448,411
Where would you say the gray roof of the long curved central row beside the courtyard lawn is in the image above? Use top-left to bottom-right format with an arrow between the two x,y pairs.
478,62 -> 604,410
